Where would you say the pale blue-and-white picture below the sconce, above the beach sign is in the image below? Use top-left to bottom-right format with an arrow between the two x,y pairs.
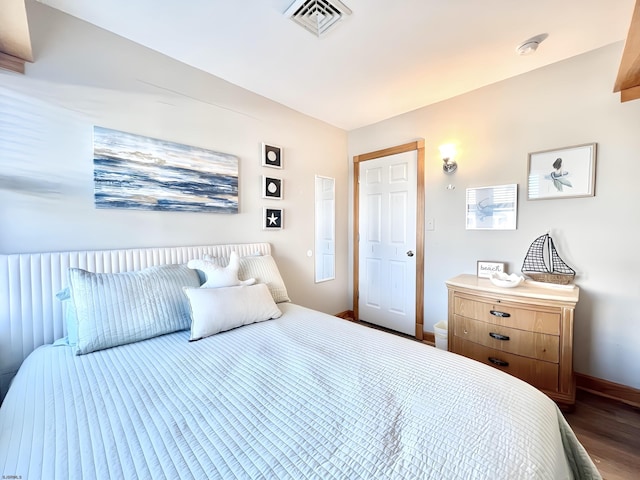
466,183 -> 518,230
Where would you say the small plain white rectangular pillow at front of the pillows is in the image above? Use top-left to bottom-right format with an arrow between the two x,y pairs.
184,283 -> 282,341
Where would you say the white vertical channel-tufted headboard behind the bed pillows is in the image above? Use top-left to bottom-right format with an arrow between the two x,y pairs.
0,243 -> 271,402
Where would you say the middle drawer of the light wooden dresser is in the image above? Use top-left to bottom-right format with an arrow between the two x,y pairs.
453,315 -> 560,363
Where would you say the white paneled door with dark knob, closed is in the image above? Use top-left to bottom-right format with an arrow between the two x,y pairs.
358,150 -> 418,335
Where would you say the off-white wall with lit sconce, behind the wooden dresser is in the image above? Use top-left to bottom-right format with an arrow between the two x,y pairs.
349,44 -> 640,388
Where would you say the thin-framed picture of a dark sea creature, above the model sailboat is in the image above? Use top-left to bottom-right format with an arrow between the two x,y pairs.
527,143 -> 597,200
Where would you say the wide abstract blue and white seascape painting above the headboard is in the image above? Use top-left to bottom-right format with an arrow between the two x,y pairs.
93,126 -> 238,213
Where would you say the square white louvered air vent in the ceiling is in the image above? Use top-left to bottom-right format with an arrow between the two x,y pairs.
284,0 -> 351,37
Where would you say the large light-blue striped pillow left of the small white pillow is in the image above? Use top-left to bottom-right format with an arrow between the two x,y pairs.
69,265 -> 200,355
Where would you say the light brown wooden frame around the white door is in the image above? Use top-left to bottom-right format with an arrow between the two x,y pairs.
353,140 -> 425,340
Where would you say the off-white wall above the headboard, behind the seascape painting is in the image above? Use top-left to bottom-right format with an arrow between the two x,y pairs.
0,2 -> 349,313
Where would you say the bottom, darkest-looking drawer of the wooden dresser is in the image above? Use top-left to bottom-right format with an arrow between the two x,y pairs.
453,336 -> 558,392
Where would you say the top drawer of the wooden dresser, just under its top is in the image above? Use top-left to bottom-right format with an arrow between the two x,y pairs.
453,295 -> 561,335
